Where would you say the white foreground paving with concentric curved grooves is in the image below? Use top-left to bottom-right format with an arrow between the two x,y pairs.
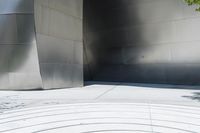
0,103 -> 200,133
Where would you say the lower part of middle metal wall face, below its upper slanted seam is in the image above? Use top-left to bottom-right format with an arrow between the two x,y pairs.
37,33 -> 83,89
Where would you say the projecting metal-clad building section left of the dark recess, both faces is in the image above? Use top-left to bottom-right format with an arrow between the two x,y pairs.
0,0 -> 83,90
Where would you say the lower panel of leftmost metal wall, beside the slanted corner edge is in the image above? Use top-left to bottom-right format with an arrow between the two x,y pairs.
7,42 -> 42,90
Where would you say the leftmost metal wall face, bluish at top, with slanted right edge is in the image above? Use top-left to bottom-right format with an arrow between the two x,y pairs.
0,0 -> 42,90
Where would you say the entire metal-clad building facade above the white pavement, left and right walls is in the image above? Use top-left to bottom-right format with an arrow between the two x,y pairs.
0,0 -> 200,90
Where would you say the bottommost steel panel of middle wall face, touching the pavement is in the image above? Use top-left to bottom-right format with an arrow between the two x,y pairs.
40,63 -> 83,89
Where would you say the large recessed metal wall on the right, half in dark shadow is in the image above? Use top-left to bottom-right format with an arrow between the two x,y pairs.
84,0 -> 200,85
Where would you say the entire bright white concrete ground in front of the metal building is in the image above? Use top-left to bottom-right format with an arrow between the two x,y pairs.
0,83 -> 200,133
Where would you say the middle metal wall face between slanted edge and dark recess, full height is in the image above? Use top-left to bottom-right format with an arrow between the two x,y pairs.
35,0 -> 83,89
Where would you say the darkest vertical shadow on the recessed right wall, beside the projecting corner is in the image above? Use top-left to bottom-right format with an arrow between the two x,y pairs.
83,0 -> 143,82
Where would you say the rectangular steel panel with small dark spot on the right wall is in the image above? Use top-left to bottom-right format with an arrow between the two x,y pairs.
121,45 -> 172,64
